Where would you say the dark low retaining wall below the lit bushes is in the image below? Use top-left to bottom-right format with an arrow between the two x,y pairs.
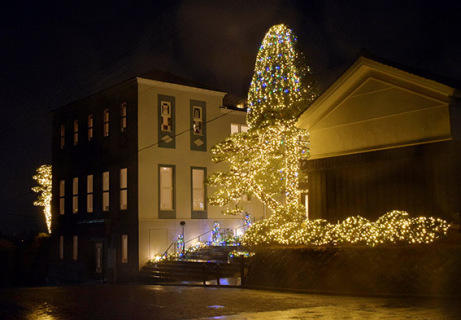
245,244 -> 461,296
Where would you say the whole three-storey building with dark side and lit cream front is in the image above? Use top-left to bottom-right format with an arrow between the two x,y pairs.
52,75 -> 263,280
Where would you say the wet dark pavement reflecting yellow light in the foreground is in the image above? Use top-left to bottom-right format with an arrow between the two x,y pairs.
0,285 -> 461,320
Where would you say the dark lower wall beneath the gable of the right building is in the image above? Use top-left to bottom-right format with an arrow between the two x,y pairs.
303,141 -> 461,222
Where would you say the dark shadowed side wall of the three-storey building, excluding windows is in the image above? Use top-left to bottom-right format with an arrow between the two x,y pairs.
52,81 -> 138,279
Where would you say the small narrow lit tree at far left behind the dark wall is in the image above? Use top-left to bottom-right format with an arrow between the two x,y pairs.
32,164 -> 52,233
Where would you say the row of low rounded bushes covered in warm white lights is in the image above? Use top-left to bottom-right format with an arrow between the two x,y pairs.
241,210 -> 450,246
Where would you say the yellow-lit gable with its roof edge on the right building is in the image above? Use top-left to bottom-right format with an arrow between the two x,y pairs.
296,55 -> 461,159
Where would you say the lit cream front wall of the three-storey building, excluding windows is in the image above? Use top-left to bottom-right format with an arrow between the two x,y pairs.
138,79 -> 262,266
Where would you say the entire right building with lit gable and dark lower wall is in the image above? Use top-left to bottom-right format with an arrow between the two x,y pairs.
297,56 -> 461,222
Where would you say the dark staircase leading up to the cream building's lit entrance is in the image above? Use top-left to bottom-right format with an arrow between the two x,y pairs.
139,246 -> 243,285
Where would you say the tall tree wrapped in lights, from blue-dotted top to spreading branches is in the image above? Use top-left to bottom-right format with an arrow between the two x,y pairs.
208,25 -> 316,220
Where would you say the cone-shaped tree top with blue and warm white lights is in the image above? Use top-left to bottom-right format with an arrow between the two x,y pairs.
247,24 -> 317,128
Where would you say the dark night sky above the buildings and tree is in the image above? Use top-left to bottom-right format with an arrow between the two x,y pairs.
0,0 -> 461,234
